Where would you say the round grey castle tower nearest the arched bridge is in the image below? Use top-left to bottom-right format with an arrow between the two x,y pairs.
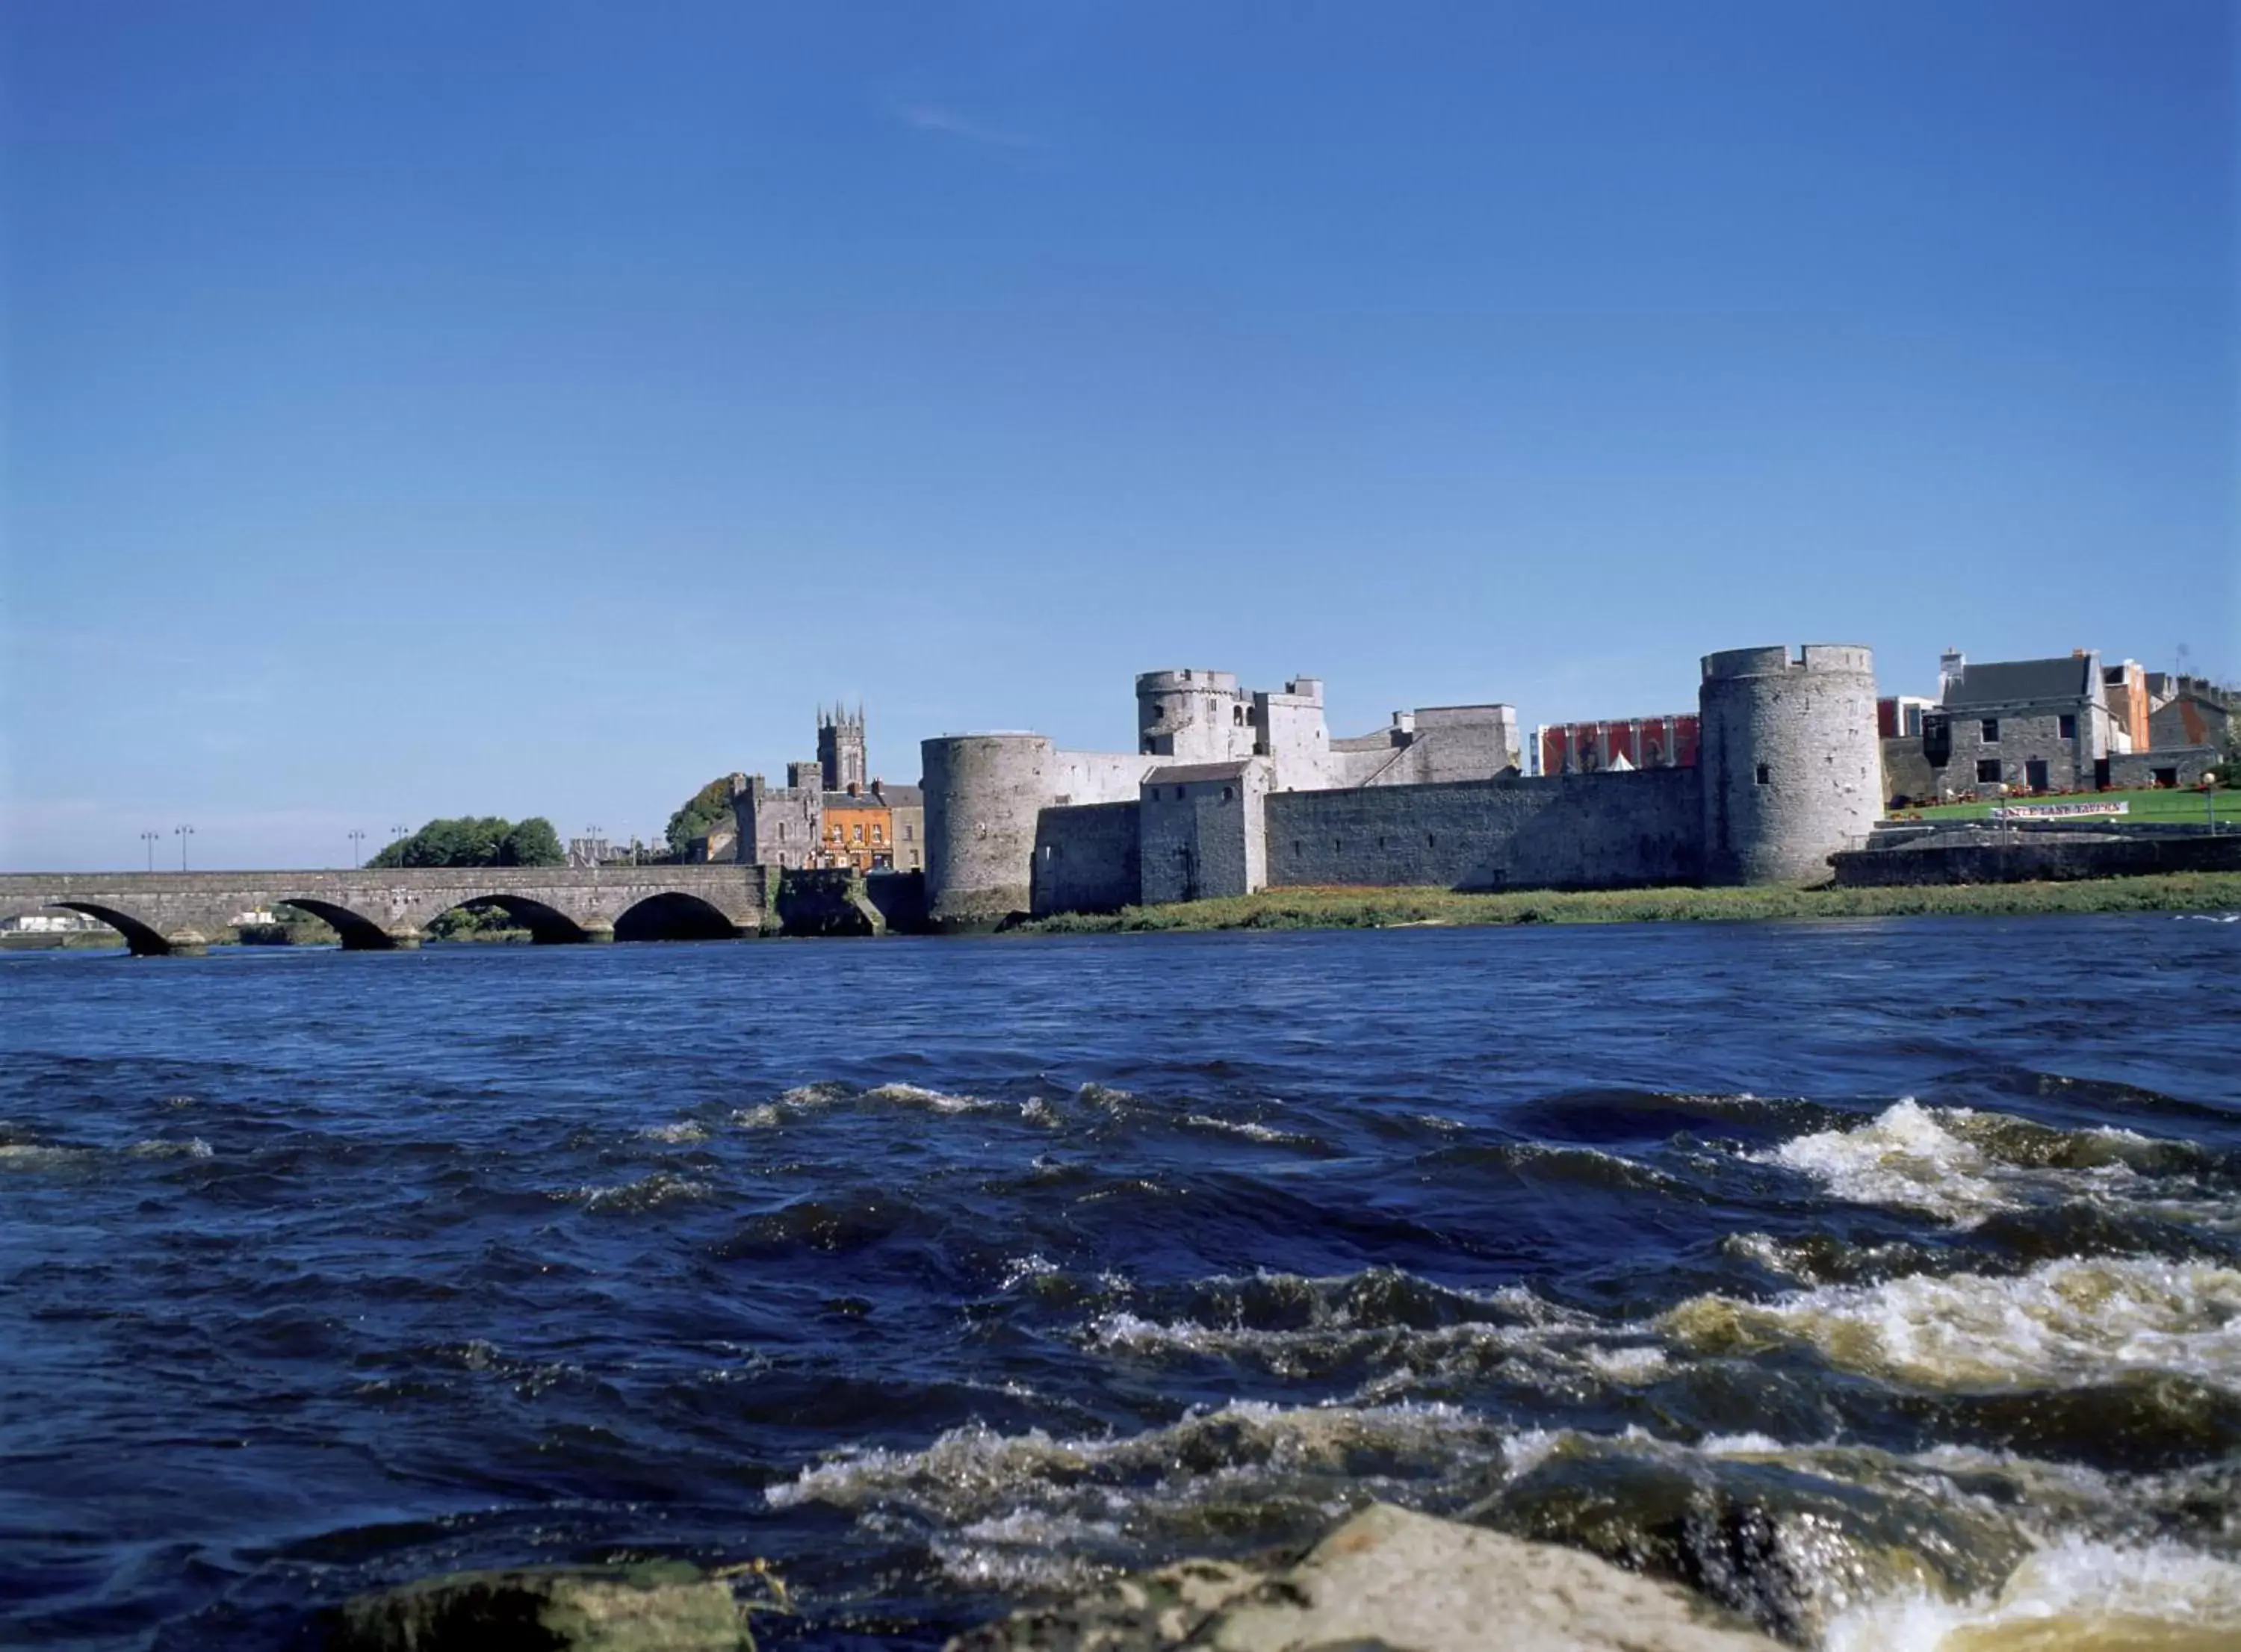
919,735 -> 1056,928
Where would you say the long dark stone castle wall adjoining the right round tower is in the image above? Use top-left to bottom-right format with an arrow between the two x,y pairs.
1264,768 -> 1703,890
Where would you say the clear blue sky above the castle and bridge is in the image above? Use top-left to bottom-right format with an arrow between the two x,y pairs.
0,0 -> 2241,870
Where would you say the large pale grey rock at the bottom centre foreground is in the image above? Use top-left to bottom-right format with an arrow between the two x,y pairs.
950,1504 -> 1777,1652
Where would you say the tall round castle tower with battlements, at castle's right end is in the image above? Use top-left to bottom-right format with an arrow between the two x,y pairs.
1696,643 -> 1882,886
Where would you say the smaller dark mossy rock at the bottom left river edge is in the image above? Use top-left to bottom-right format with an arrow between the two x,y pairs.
327,1562 -> 753,1652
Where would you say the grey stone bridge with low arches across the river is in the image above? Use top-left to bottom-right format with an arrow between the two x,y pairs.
0,866 -> 798,955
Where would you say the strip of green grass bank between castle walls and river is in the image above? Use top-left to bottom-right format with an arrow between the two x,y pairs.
1015,872 -> 2241,935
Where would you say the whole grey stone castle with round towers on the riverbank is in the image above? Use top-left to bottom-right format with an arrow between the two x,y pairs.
923,643 -> 1882,928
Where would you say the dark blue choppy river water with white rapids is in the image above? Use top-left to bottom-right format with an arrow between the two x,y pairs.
0,915 -> 2241,1652
